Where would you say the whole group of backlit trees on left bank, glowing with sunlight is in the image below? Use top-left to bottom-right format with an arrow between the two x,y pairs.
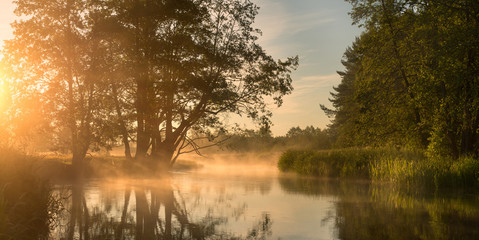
0,0 -> 298,174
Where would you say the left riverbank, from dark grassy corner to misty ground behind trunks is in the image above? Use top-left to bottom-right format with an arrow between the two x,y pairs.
0,147 -> 210,240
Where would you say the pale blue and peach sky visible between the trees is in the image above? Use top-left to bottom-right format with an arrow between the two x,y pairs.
0,0 -> 361,136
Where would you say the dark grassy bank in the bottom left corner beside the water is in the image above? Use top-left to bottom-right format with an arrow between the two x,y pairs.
0,149 -> 59,239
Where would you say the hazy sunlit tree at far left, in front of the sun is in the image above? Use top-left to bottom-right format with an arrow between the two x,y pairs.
3,0 -> 116,175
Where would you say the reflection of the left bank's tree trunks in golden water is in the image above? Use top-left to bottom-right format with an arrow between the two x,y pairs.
60,178 -> 272,240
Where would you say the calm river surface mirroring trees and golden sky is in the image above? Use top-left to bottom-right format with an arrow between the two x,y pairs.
45,170 -> 479,239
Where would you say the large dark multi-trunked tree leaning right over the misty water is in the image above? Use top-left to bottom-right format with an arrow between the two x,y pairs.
110,0 -> 298,168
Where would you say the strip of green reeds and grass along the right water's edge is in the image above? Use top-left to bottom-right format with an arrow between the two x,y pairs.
278,149 -> 479,187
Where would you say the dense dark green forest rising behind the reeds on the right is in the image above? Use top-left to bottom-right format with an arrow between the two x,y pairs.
322,0 -> 479,159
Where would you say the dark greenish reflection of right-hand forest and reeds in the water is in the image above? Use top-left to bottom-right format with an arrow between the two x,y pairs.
279,175 -> 479,240
